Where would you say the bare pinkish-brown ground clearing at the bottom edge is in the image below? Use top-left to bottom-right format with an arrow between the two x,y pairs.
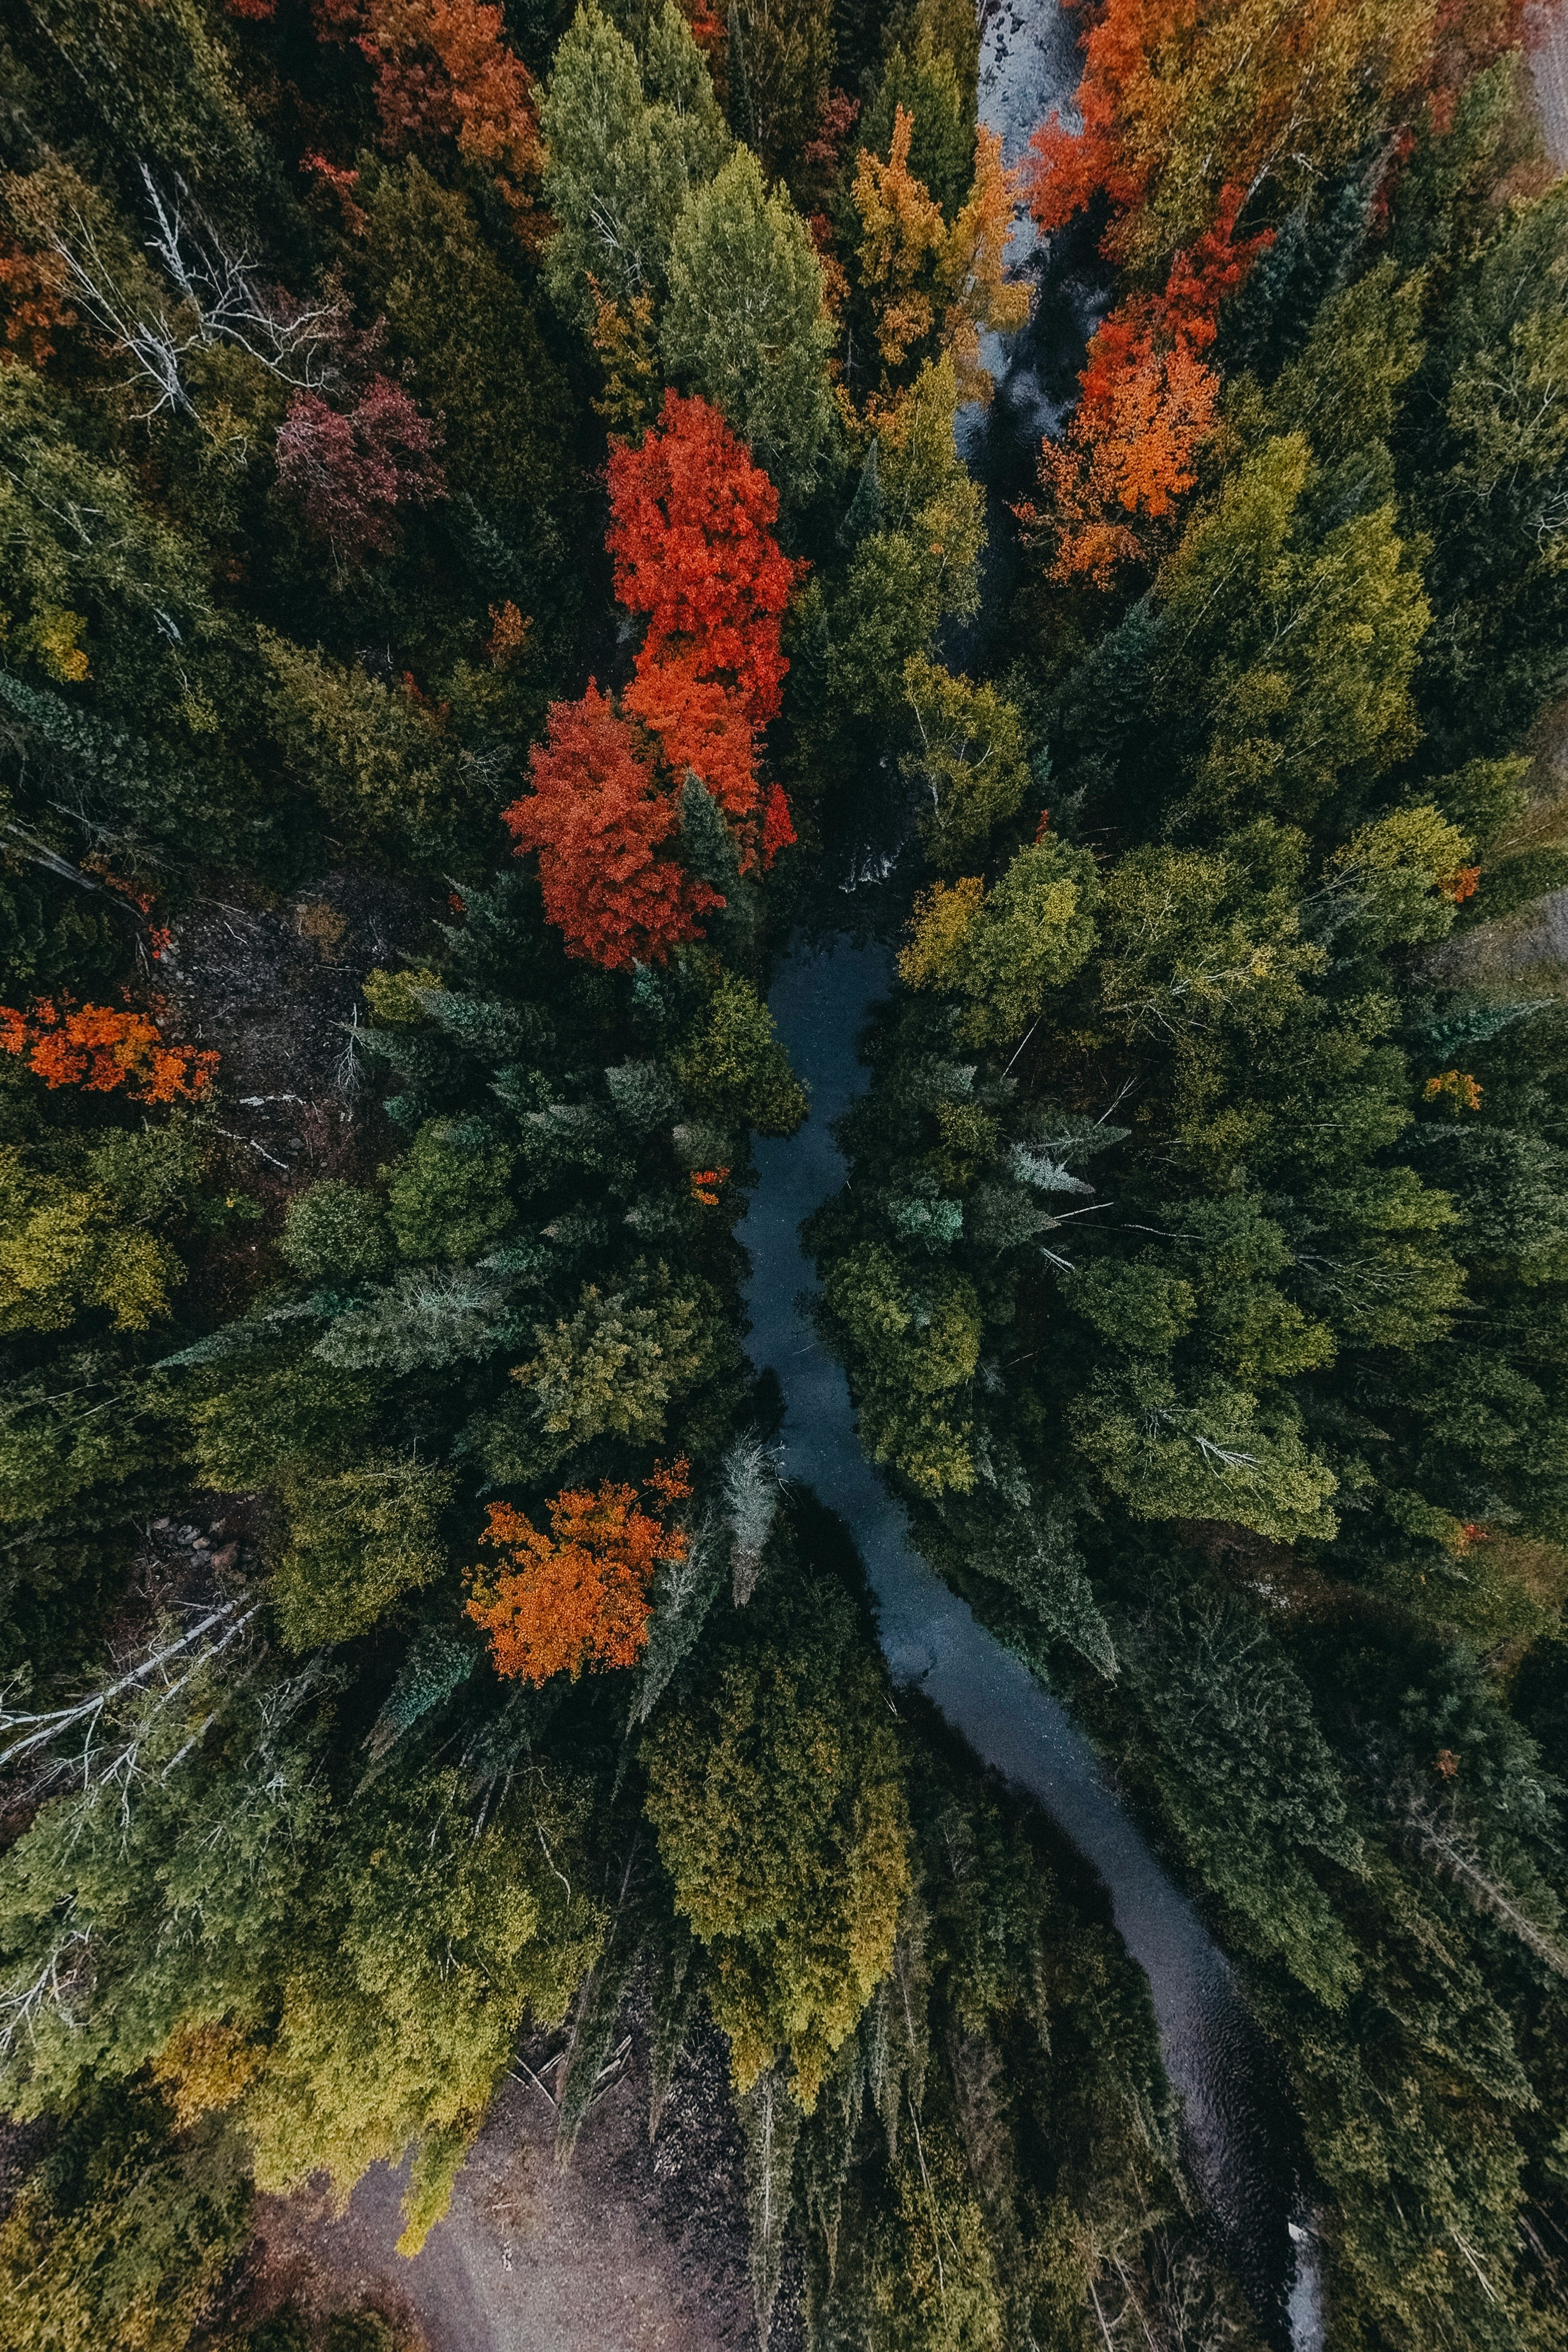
251,2030 -> 799,2352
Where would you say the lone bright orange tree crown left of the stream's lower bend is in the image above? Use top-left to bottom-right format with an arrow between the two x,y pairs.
468,1458 -> 691,1682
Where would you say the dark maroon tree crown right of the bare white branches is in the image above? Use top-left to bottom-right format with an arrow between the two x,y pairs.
277,376 -> 447,562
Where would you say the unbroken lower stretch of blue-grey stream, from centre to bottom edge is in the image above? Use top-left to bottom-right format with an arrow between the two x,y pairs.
741,938 -> 1323,2352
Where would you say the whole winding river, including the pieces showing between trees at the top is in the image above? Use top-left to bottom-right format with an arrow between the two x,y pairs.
741,0 -> 1323,2352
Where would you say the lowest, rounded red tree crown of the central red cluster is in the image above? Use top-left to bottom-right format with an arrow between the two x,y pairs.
503,682 -> 724,971
